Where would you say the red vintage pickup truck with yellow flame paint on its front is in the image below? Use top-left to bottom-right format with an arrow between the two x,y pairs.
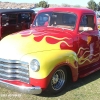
0,7 -> 100,94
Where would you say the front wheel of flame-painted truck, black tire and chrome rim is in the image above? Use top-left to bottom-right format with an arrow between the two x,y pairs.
47,67 -> 67,94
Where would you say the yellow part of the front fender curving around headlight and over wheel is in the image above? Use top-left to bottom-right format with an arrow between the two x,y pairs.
21,50 -> 78,79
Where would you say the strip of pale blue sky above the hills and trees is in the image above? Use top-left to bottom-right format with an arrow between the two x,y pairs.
0,0 -> 100,6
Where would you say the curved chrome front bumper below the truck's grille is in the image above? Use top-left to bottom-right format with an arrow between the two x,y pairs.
0,80 -> 42,94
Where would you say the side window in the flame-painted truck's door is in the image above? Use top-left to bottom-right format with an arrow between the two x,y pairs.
79,15 -> 94,31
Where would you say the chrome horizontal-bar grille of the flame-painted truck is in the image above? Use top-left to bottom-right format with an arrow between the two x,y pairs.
0,59 -> 29,83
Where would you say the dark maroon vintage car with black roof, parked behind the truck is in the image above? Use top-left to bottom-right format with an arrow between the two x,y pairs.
0,9 -> 36,39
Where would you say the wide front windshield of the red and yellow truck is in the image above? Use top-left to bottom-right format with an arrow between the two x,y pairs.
33,12 -> 77,29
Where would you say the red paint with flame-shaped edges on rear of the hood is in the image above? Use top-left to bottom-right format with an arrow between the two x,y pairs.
21,30 -> 73,49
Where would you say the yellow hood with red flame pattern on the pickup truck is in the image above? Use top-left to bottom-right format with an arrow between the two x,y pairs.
0,27 -> 73,59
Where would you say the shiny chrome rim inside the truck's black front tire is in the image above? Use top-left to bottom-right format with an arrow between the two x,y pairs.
51,69 -> 66,91
